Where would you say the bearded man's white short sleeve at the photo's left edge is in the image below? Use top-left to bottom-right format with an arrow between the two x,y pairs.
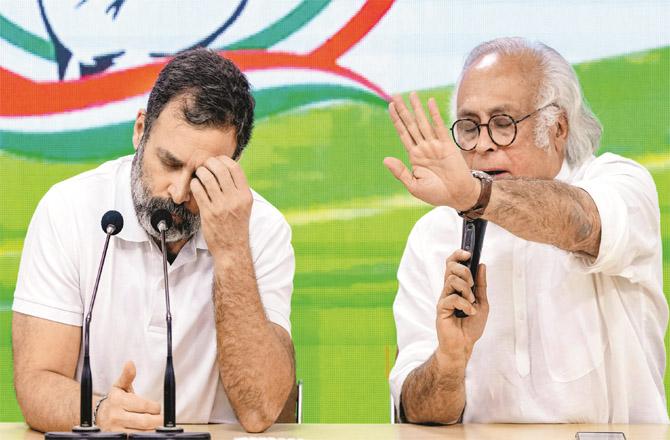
12,189 -> 83,326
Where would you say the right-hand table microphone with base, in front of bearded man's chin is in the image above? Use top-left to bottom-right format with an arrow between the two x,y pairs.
128,209 -> 211,440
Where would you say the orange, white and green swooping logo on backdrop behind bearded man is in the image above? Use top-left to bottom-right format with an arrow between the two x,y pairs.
0,0 -> 393,161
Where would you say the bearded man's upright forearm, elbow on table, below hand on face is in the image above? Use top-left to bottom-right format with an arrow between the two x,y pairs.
213,247 -> 295,431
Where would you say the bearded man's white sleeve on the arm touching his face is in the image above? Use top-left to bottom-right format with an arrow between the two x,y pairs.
251,200 -> 295,335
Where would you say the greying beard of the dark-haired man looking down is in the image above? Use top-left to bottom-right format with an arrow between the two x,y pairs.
130,145 -> 200,243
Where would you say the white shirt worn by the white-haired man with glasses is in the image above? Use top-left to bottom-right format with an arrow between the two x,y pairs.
390,154 -> 668,423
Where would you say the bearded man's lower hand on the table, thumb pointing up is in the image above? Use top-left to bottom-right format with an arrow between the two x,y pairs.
96,361 -> 163,432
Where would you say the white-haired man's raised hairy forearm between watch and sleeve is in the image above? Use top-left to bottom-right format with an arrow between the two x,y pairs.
483,178 -> 600,257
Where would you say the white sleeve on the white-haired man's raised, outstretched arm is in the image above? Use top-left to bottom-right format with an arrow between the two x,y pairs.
571,153 -> 660,282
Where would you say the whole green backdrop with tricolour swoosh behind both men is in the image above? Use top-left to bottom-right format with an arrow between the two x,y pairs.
0,0 -> 670,423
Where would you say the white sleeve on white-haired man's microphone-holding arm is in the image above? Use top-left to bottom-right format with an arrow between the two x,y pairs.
389,214 -> 438,406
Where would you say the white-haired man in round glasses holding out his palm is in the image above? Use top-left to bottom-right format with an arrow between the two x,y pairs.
384,38 -> 668,423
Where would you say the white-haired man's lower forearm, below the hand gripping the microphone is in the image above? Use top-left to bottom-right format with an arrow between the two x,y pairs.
401,353 -> 465,424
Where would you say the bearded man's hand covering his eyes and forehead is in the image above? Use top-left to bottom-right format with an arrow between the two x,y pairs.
190,156 -> 253,258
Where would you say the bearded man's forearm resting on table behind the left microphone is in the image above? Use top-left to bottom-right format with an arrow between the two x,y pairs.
15,371 -> 99,432
